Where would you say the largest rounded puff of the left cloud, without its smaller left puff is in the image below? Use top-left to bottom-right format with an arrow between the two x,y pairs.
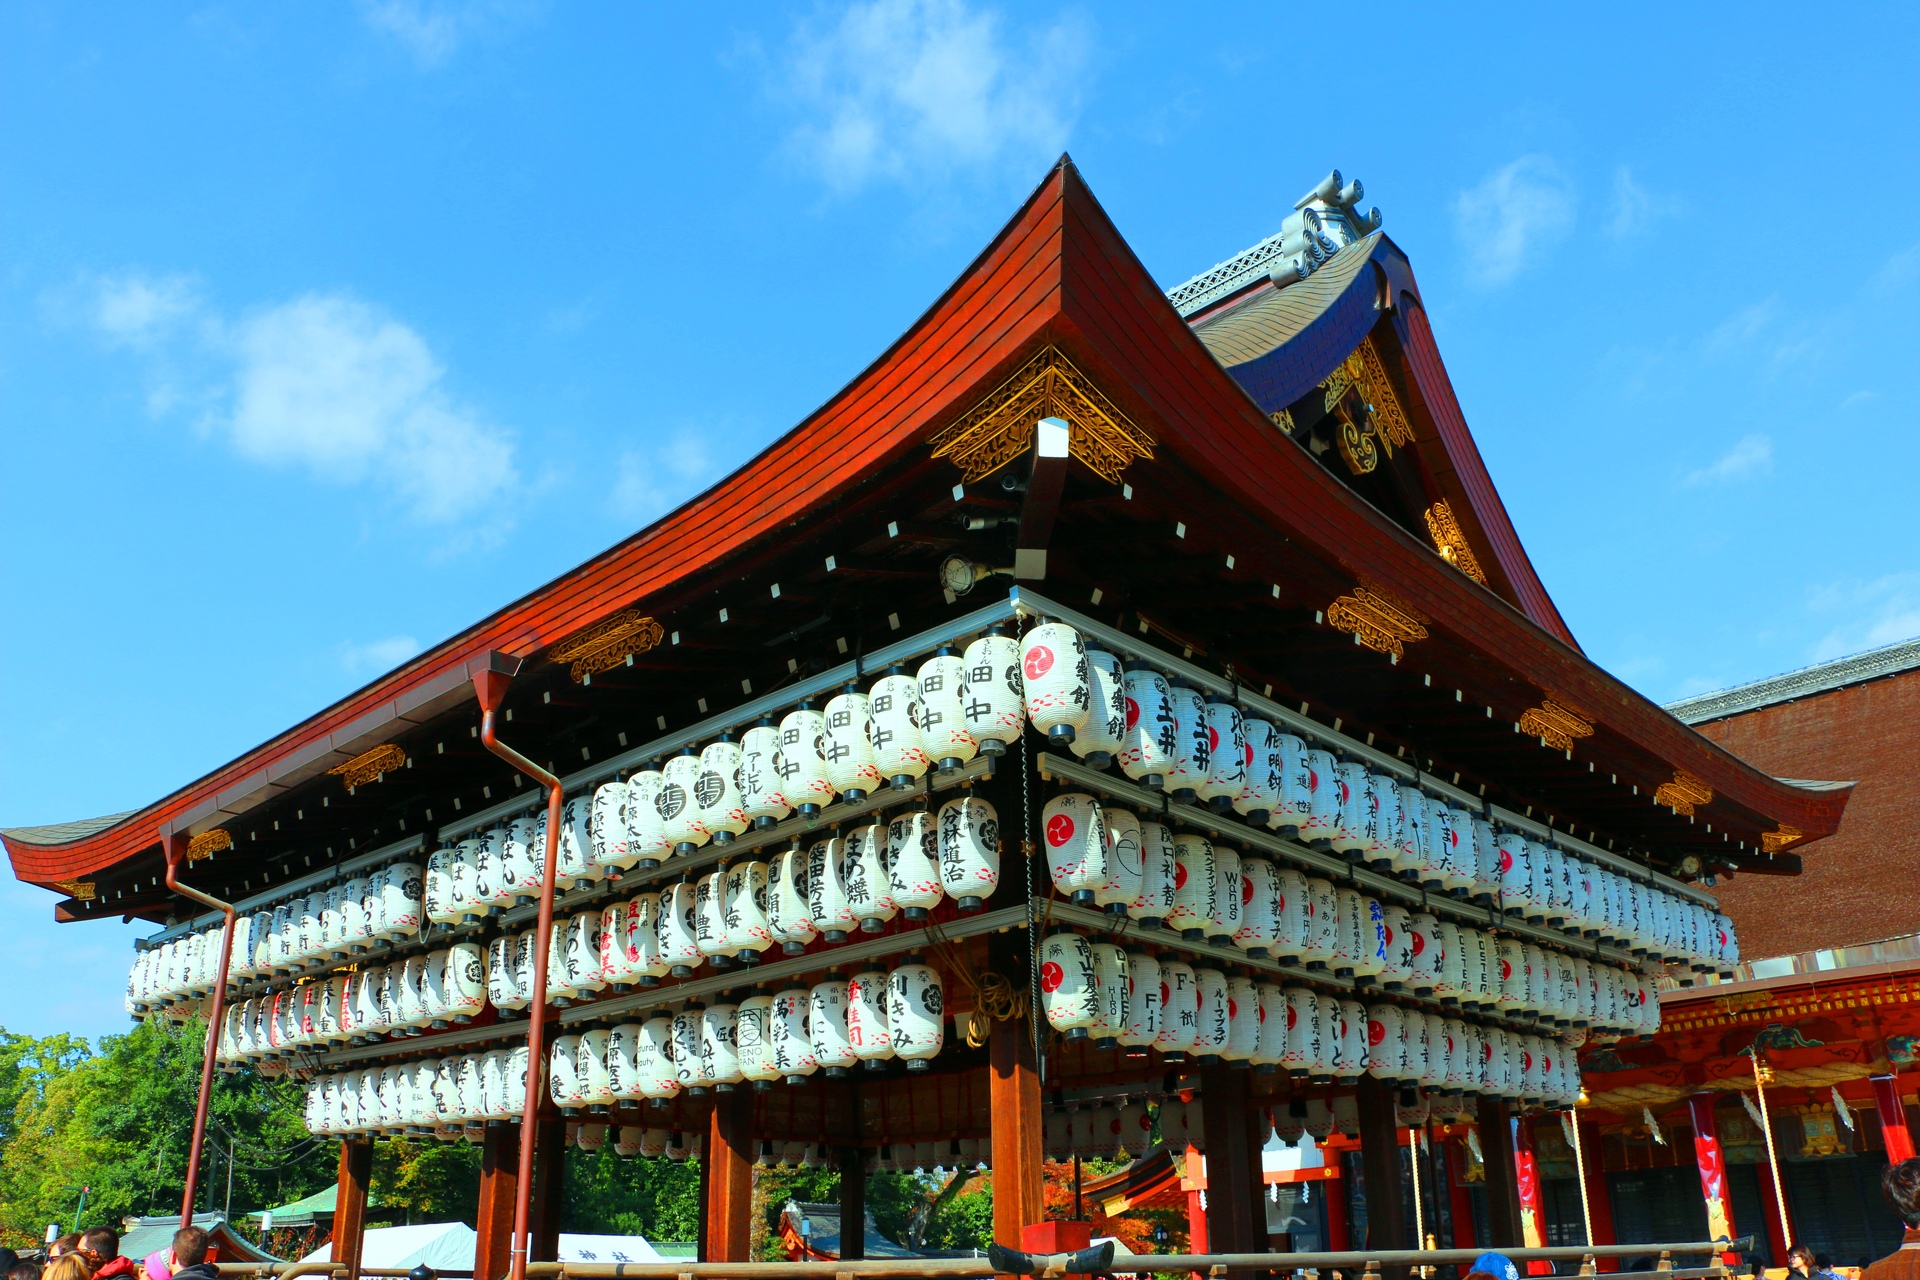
225,294 -> 516,522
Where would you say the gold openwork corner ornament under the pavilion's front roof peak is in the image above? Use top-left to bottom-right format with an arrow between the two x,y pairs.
927,345 -> 1156,484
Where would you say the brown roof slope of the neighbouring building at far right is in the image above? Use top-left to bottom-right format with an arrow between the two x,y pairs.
1699,672 -> 1920,960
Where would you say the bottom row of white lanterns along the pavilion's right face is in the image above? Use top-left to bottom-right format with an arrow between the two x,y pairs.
1041,933 -> 1584,1098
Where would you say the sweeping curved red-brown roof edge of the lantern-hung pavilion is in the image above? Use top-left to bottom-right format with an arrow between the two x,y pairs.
4,159 -> 1845,905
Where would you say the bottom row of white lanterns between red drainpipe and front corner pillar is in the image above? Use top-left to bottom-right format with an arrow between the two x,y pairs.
549,958 -> 945,1111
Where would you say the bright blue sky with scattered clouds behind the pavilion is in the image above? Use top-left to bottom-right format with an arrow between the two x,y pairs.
0,0 -> 1920,1032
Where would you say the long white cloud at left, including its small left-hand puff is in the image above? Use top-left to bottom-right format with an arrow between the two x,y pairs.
69,273 -> 518,524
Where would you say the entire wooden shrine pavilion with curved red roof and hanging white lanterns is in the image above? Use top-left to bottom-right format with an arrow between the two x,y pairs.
4,159 -> 1878,1280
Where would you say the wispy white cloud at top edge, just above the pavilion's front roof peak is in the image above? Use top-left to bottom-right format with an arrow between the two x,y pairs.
789,0 -> 1087,190
